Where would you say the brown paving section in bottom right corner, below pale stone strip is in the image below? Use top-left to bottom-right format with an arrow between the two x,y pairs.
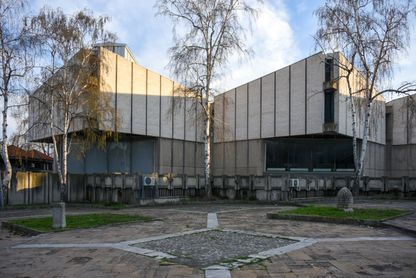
231,241 -> 416,277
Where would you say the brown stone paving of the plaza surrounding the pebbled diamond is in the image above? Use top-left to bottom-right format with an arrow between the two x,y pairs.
0,202 -> 416,278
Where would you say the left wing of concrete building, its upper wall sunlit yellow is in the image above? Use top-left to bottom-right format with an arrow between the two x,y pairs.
30,44 -> 203,175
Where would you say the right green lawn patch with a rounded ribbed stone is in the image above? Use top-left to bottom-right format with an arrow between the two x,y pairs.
279,206 -> 408,221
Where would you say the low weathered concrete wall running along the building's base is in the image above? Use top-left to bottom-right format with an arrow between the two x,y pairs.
6,169 -> 416,205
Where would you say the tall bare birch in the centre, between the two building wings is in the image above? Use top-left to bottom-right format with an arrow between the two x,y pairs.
156,0 -> 256,198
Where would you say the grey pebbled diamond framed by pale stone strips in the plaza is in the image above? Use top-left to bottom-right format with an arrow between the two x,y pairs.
134,230 -> 295,267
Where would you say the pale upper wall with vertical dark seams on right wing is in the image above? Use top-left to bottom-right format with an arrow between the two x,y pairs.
215,54 -> 324,142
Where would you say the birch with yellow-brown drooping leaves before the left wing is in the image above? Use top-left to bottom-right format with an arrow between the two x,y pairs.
29,8 -> 114,202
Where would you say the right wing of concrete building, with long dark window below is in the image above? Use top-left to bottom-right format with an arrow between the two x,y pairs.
214,53 -> 385,176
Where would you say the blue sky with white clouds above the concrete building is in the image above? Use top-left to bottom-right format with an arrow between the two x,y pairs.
30,0 -> 416,91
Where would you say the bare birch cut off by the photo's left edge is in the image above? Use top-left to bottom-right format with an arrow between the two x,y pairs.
0,0 -> 32,206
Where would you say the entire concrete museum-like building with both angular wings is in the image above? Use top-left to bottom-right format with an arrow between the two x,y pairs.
28,44 -> 416,177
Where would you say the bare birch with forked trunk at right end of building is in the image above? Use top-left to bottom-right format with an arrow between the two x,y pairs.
315,0 -> 415,193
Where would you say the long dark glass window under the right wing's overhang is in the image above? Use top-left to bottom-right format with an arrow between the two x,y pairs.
266,138 -> 354,172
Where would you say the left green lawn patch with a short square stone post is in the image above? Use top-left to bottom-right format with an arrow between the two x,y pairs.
9,213 -> 155,232
